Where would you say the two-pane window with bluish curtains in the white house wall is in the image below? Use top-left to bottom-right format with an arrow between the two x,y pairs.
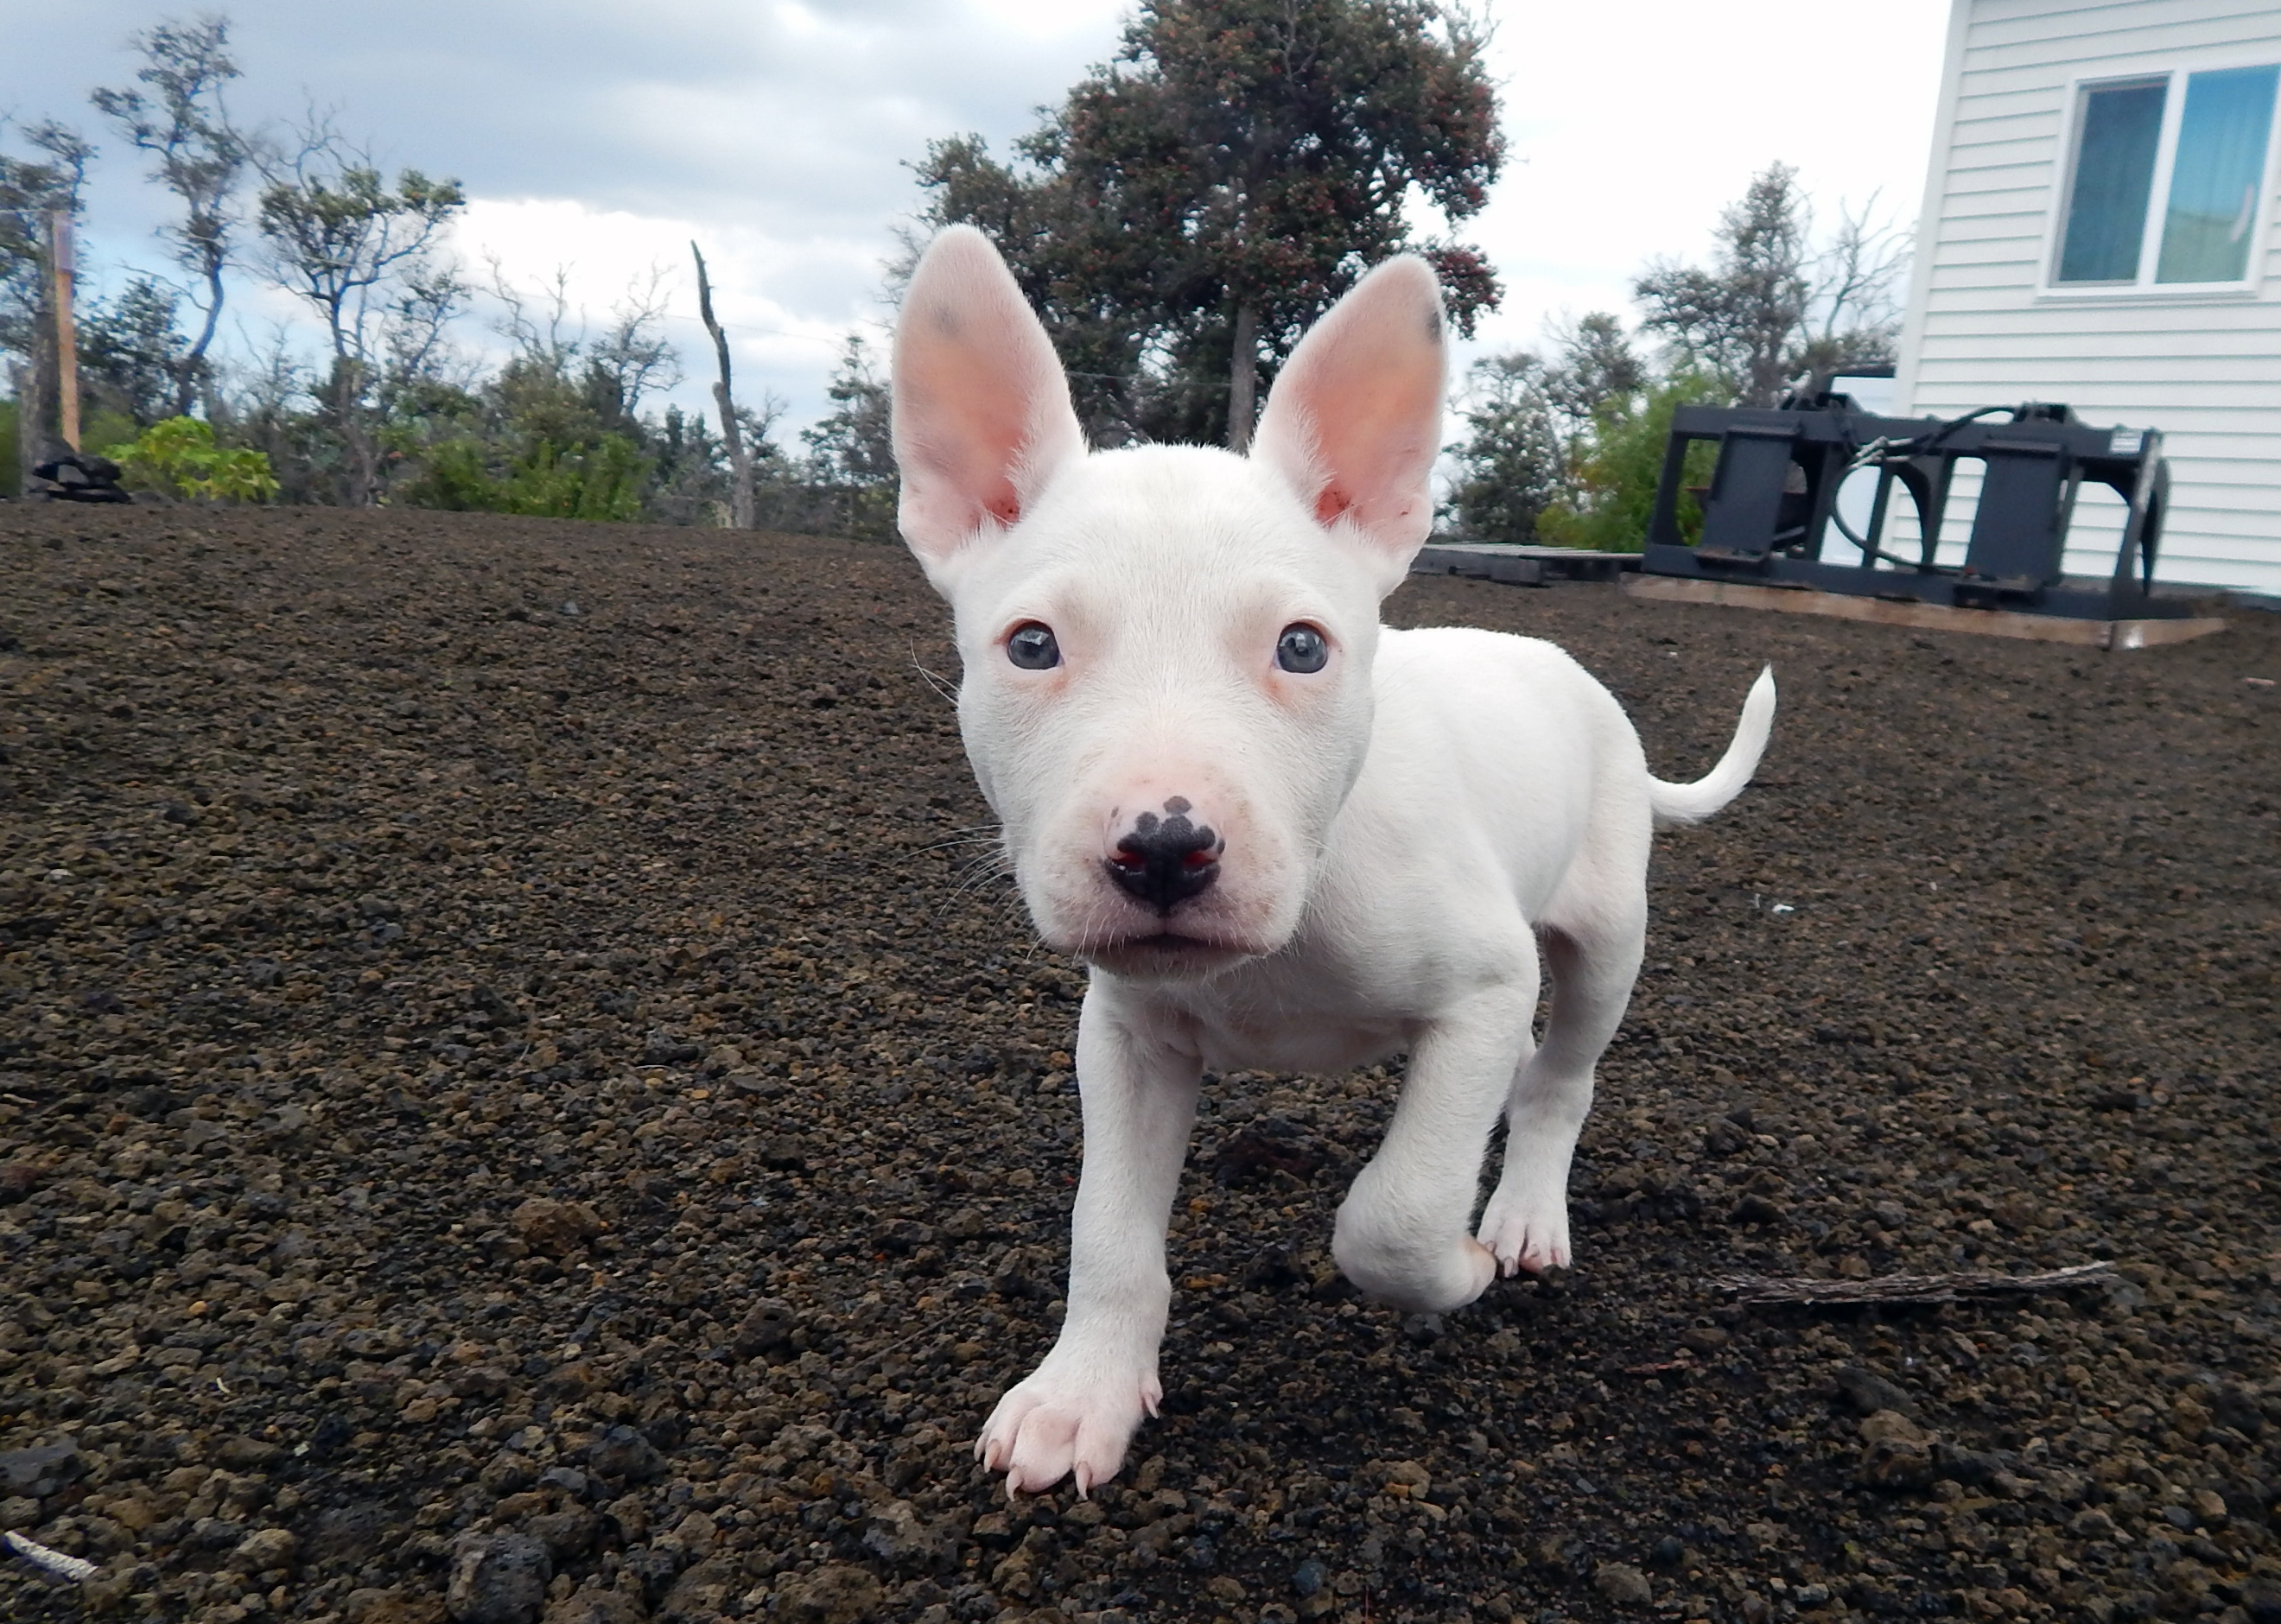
2050,67 -> 2281,288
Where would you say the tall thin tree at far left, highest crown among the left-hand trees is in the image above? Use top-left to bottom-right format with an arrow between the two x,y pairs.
92,16 -> 251,416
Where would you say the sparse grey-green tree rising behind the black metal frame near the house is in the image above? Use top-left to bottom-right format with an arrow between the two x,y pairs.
1633,164 -> 1907,406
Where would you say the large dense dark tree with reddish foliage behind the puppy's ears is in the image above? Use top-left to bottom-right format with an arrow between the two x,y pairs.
919,0 -> 1503,449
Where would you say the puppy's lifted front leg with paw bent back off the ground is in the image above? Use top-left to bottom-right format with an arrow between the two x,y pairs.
1332,971 -> 1537,1314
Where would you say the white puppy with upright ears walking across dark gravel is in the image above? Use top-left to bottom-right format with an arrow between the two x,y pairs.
894,228 -> 1775,1492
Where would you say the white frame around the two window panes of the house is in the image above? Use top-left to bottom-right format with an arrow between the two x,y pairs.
2037,48 -> 2281,301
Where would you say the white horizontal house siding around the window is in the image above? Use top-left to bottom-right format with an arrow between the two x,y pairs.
1897,0 -> 2281,593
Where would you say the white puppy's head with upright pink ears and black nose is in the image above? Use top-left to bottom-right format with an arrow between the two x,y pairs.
894,228 -> 1444,979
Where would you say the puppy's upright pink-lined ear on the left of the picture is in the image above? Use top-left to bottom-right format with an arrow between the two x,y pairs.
894,225 -> 1086,588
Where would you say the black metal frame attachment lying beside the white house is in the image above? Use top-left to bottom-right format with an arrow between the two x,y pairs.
1640,395 -> 2195,620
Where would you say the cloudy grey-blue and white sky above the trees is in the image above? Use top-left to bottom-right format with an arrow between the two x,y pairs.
0,0 -> 1948,428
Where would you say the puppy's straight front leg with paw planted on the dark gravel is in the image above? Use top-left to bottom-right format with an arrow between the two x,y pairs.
974,983 -> 1202,1494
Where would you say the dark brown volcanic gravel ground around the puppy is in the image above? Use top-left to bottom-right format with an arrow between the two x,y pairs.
0,506 -> 2281,1624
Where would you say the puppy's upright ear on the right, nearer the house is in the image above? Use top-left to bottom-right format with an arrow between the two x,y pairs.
1252,253 -> 1444,580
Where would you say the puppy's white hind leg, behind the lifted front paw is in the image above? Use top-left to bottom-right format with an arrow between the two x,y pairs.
1480,894 -> 1647,1275
